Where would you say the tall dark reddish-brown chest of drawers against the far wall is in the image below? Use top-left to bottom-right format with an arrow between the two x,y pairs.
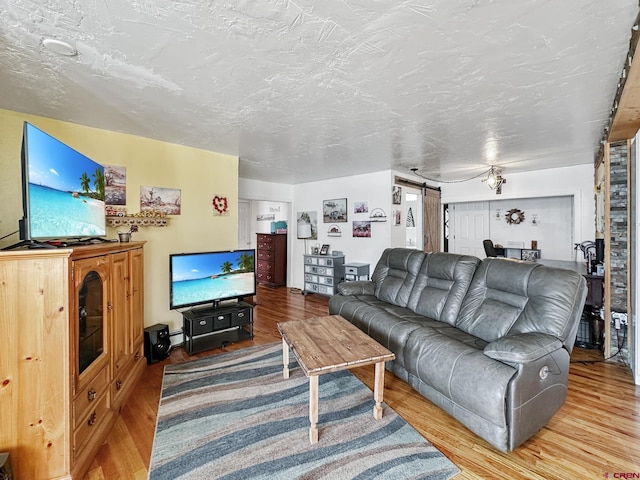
256,233 -> 287,287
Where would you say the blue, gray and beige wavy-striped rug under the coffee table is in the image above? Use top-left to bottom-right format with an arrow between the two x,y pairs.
149,343 -> 459,480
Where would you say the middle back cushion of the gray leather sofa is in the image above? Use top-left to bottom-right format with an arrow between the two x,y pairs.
407,253 -> 480,325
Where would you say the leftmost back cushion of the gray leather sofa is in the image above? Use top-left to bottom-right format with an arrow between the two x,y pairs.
371,248 -> 426,307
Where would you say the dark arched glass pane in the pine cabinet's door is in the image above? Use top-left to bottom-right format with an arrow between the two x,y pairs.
78,270 -> 106,374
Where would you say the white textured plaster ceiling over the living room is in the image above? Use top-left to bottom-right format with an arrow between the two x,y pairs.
0,0 -> 638,183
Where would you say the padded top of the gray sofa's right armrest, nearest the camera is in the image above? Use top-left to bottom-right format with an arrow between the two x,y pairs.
484,332 -> 562,363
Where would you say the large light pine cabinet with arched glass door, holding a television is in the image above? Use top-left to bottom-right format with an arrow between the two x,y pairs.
0,242 -> 146,479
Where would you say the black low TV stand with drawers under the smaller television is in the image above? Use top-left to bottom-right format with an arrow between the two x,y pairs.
182,302 -> 253,355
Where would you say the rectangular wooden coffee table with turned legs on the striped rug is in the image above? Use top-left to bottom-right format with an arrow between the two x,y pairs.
278,315 -> 396,444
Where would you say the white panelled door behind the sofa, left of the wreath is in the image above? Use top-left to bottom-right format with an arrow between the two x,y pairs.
449,202 -> 490,258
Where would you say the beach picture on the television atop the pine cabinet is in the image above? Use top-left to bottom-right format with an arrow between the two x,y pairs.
27,125 -> 106,238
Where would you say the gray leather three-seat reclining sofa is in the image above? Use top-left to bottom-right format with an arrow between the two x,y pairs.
329,248 -> 587,452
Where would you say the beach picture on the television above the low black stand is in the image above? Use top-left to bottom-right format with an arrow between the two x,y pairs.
171,250 -> 255,306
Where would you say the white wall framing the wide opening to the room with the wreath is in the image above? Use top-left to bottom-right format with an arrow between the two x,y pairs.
441,164 -> 595,253
